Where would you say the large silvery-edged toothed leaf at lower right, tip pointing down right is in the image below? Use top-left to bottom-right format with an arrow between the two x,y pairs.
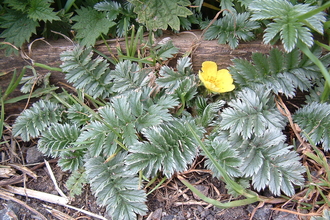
224,129 -> 305,196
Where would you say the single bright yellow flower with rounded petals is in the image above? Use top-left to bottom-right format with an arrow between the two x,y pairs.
199,61 -> 235,93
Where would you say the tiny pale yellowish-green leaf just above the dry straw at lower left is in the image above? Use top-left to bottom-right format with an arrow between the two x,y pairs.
65,169 -> 87,197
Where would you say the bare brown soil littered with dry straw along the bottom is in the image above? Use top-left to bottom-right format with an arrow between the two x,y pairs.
0,134 -> 299,220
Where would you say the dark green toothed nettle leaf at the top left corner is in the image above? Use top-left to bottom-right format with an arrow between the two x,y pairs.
0,10 -> 39,55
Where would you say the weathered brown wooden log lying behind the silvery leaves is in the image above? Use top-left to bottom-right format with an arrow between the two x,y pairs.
0,31 -> 271,117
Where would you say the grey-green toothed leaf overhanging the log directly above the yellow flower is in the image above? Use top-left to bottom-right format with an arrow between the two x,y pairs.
204,12 -> 259,49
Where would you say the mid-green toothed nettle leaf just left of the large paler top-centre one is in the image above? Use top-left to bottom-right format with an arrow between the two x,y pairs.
72,7 -> 116,46
